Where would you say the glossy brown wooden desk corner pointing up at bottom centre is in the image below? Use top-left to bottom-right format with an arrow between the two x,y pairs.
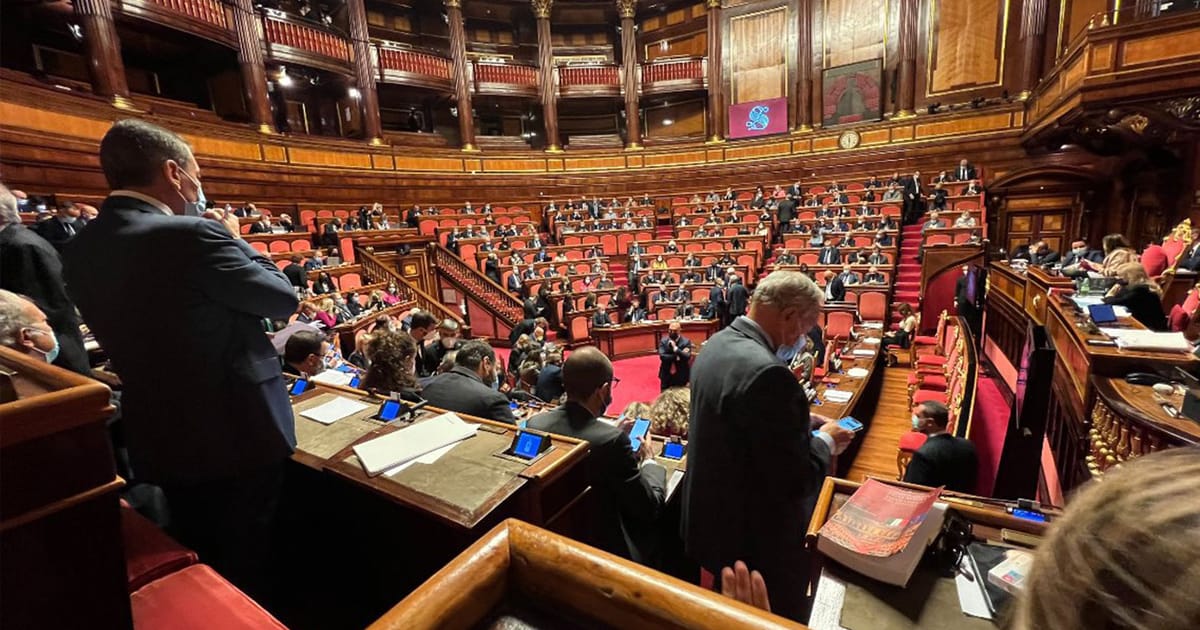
371,520 -> 803,630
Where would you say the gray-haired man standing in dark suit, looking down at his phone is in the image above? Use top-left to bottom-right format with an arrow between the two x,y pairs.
680,271 -> 853,620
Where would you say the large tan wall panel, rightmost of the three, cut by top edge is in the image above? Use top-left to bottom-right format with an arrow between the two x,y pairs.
926,0 -> 1008,95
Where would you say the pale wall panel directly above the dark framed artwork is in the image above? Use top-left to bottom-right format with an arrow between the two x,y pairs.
822,0 -> 890,67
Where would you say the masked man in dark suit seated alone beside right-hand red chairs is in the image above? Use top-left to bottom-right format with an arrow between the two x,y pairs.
902,401 -> 979,493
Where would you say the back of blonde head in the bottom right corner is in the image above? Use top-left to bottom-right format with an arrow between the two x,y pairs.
1014,446 -> 1200,630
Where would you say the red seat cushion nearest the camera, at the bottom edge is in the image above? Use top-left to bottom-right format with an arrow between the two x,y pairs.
130,564 -> 286,630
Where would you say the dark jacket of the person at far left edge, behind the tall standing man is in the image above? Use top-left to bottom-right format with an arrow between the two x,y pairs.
0,221 -> 91,376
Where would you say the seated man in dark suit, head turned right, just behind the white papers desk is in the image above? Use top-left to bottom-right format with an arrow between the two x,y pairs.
421,340 -> 516,424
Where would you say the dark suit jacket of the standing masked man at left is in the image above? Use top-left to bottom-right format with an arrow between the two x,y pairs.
66,197 -> 298,484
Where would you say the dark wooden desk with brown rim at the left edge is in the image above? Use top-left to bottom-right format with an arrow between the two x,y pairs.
0,348 -> 132,628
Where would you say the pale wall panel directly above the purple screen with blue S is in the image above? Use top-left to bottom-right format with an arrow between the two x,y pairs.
724,5 -> 796,103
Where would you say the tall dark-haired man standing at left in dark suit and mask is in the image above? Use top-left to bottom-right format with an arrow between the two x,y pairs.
65,119 -> 298,590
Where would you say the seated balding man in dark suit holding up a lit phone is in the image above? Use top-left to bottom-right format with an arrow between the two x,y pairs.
528,346 -> 667,563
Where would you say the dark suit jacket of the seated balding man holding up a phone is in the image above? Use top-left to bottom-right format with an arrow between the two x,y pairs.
528,402 -> 666,562
